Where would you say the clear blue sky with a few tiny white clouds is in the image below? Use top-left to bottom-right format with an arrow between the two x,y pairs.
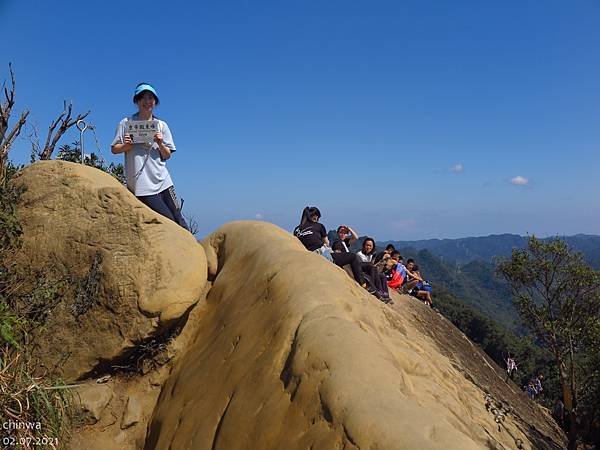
0,0 -> 600,240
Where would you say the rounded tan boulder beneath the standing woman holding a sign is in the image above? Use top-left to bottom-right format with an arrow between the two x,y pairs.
14,161 -> 207,379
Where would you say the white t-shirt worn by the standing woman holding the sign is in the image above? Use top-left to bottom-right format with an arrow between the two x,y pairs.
112,113 -> 175,197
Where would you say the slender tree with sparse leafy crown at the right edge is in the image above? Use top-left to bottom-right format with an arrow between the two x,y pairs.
497,236 -> 600,448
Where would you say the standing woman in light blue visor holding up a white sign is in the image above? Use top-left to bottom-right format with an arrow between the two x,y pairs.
111,83 -> 189,230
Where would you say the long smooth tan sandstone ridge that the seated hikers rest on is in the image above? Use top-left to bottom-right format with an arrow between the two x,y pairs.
145,222 -> 564,450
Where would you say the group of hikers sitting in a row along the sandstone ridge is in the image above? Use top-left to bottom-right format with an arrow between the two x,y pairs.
294,206 -> 433,306
